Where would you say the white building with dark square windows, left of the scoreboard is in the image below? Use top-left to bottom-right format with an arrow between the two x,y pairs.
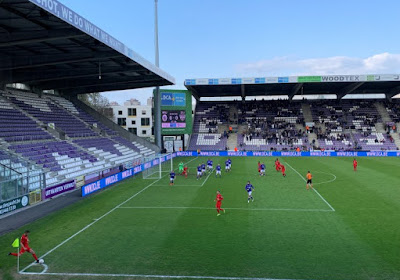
110,98 -> 154,138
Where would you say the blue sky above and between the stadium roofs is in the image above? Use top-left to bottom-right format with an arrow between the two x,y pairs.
57,0 -> 400,103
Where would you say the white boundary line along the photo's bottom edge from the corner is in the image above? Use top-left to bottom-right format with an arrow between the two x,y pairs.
18,272 -> 318,280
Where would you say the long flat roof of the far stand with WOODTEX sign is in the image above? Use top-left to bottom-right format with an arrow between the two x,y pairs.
185,74 -> 400,99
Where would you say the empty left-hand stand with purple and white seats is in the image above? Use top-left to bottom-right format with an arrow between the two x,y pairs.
0,90 -> 159,190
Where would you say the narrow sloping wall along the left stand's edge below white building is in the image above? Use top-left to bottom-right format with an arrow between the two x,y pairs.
70,96 -> 160,153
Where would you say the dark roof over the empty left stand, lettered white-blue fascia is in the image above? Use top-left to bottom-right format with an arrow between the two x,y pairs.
0,0 -> 175,94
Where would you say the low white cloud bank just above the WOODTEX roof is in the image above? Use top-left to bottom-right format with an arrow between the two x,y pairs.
235,53 -> 400,77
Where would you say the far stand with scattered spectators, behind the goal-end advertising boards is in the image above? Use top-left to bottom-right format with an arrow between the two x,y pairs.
189,100 -> 400,151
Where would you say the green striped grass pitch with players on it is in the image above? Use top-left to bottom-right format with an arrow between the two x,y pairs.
0,157 -> 400,280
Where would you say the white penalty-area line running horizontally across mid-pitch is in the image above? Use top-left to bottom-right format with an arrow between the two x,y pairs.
119,206 -> 332,212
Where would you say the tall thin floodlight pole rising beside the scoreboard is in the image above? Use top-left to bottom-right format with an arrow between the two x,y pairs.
153,0 -> 162,149
